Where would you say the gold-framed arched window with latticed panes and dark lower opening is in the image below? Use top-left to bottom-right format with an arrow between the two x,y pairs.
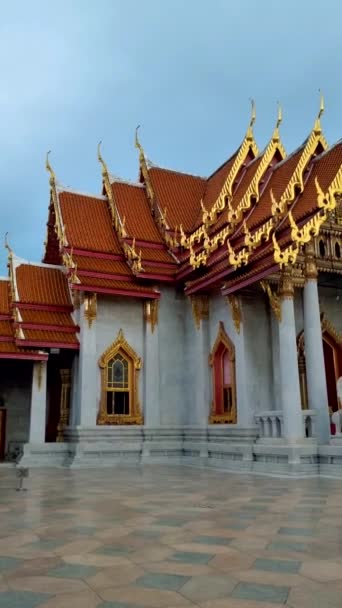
97,330 -> 142,424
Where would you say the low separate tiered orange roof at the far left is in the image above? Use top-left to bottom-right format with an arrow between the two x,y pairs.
0,251 -> 79,360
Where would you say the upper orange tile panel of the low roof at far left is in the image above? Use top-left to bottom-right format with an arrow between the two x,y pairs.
15,264 -> 71,306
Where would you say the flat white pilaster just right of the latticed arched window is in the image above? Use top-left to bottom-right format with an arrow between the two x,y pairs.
143,301 -> 160,427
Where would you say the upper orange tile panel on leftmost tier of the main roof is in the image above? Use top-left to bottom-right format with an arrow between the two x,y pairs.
59,191 -> 122,254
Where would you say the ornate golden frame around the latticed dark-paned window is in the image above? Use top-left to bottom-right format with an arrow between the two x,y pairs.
97,329 -> 143,425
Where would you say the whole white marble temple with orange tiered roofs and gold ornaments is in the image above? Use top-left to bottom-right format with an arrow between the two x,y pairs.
0,100 -> 342,477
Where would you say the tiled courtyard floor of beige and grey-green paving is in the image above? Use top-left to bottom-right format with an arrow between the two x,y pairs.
0,466 -> 342,608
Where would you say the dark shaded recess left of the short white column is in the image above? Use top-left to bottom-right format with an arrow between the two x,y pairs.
0,359 -> 32,453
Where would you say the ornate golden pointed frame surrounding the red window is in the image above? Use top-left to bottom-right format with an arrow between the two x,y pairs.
209,321 -> 237,424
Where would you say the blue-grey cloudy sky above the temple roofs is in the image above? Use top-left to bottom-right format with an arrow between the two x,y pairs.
0,0 -> 342,275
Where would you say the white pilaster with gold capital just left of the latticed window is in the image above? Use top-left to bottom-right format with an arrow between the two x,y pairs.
78,295 -> 100,428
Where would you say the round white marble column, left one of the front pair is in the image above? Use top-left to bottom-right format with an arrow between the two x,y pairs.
279,270 -> 304,443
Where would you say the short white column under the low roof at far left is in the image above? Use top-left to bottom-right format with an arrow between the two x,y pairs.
29,361 -> 47,444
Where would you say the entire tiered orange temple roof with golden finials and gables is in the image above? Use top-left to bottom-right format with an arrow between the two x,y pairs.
0,97 -> 342,360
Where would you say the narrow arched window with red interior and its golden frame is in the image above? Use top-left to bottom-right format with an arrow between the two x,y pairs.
209,321 -> 237,424
